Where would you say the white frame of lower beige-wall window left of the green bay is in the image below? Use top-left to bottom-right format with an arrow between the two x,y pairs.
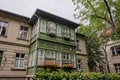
14,53 -> 25,69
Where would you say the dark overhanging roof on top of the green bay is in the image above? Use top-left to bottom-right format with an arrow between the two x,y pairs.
29,9 -> 79,28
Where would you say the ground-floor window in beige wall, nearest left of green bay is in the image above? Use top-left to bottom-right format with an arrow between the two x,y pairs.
14,53 -> 25,68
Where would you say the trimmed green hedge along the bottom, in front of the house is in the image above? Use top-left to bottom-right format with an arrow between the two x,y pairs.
35,68 -> 120,80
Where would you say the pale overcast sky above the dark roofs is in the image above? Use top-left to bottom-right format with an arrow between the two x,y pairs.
0,0 -> 78,22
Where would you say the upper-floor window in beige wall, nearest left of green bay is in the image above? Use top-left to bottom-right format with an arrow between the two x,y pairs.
19,26 -> 28,40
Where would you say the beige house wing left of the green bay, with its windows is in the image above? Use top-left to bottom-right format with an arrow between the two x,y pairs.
0,10 -> 30,80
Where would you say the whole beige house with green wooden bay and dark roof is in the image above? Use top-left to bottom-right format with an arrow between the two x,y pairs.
0,9 -> 89,80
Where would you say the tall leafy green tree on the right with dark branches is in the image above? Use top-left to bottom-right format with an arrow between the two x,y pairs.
72,0 -> 120,72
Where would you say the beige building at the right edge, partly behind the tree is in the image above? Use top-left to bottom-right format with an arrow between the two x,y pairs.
106,41 -> 120,73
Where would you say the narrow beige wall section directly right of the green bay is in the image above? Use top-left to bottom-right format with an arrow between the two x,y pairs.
76,33 -> 89,72
